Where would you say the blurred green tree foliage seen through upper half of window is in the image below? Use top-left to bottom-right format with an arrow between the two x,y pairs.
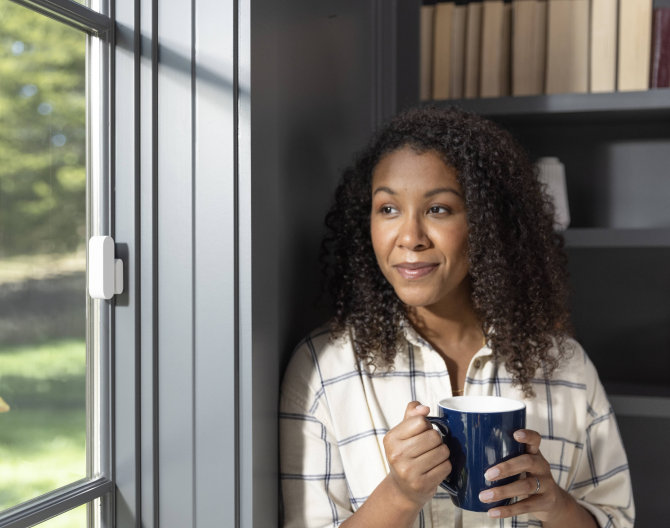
0,0 -> 86,257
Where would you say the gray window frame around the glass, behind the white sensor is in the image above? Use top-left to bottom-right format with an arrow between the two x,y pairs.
0,0 -> 114,528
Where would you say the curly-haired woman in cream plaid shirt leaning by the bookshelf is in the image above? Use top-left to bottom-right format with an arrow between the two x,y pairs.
280,108 -> 634,528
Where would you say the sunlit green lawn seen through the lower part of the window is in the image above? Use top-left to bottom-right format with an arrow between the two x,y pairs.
0,339 -> 86,528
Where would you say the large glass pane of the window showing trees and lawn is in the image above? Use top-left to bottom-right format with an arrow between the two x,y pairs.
0,0 -> 87,512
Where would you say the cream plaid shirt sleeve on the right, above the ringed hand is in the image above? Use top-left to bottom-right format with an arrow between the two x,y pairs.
568,356 -> 635,528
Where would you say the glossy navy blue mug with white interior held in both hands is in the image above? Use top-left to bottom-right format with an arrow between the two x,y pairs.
428,396 -> 526,512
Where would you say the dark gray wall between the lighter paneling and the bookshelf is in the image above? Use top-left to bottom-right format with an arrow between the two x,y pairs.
277,0 -> 375,359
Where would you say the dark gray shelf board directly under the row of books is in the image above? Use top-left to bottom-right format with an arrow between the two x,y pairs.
424,88 -> 670,121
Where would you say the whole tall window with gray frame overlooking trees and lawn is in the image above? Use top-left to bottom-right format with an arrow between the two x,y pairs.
0,0 -> 111,528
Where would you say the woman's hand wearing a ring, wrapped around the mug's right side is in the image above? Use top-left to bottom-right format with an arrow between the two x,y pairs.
479,429 -> 568,522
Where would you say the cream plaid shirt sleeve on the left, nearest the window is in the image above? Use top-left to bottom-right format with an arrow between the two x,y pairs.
279,393 -> 353,528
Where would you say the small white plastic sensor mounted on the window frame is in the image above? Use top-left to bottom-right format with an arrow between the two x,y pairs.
88,236 -> 123,299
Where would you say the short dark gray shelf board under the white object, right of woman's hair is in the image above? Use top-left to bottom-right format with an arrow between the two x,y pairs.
563,228 -> 670,248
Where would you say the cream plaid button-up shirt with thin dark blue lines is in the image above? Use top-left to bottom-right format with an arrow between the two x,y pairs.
279,327 -> 635,528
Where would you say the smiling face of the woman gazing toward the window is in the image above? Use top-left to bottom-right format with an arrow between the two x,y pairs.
370,148 -> 469,307
